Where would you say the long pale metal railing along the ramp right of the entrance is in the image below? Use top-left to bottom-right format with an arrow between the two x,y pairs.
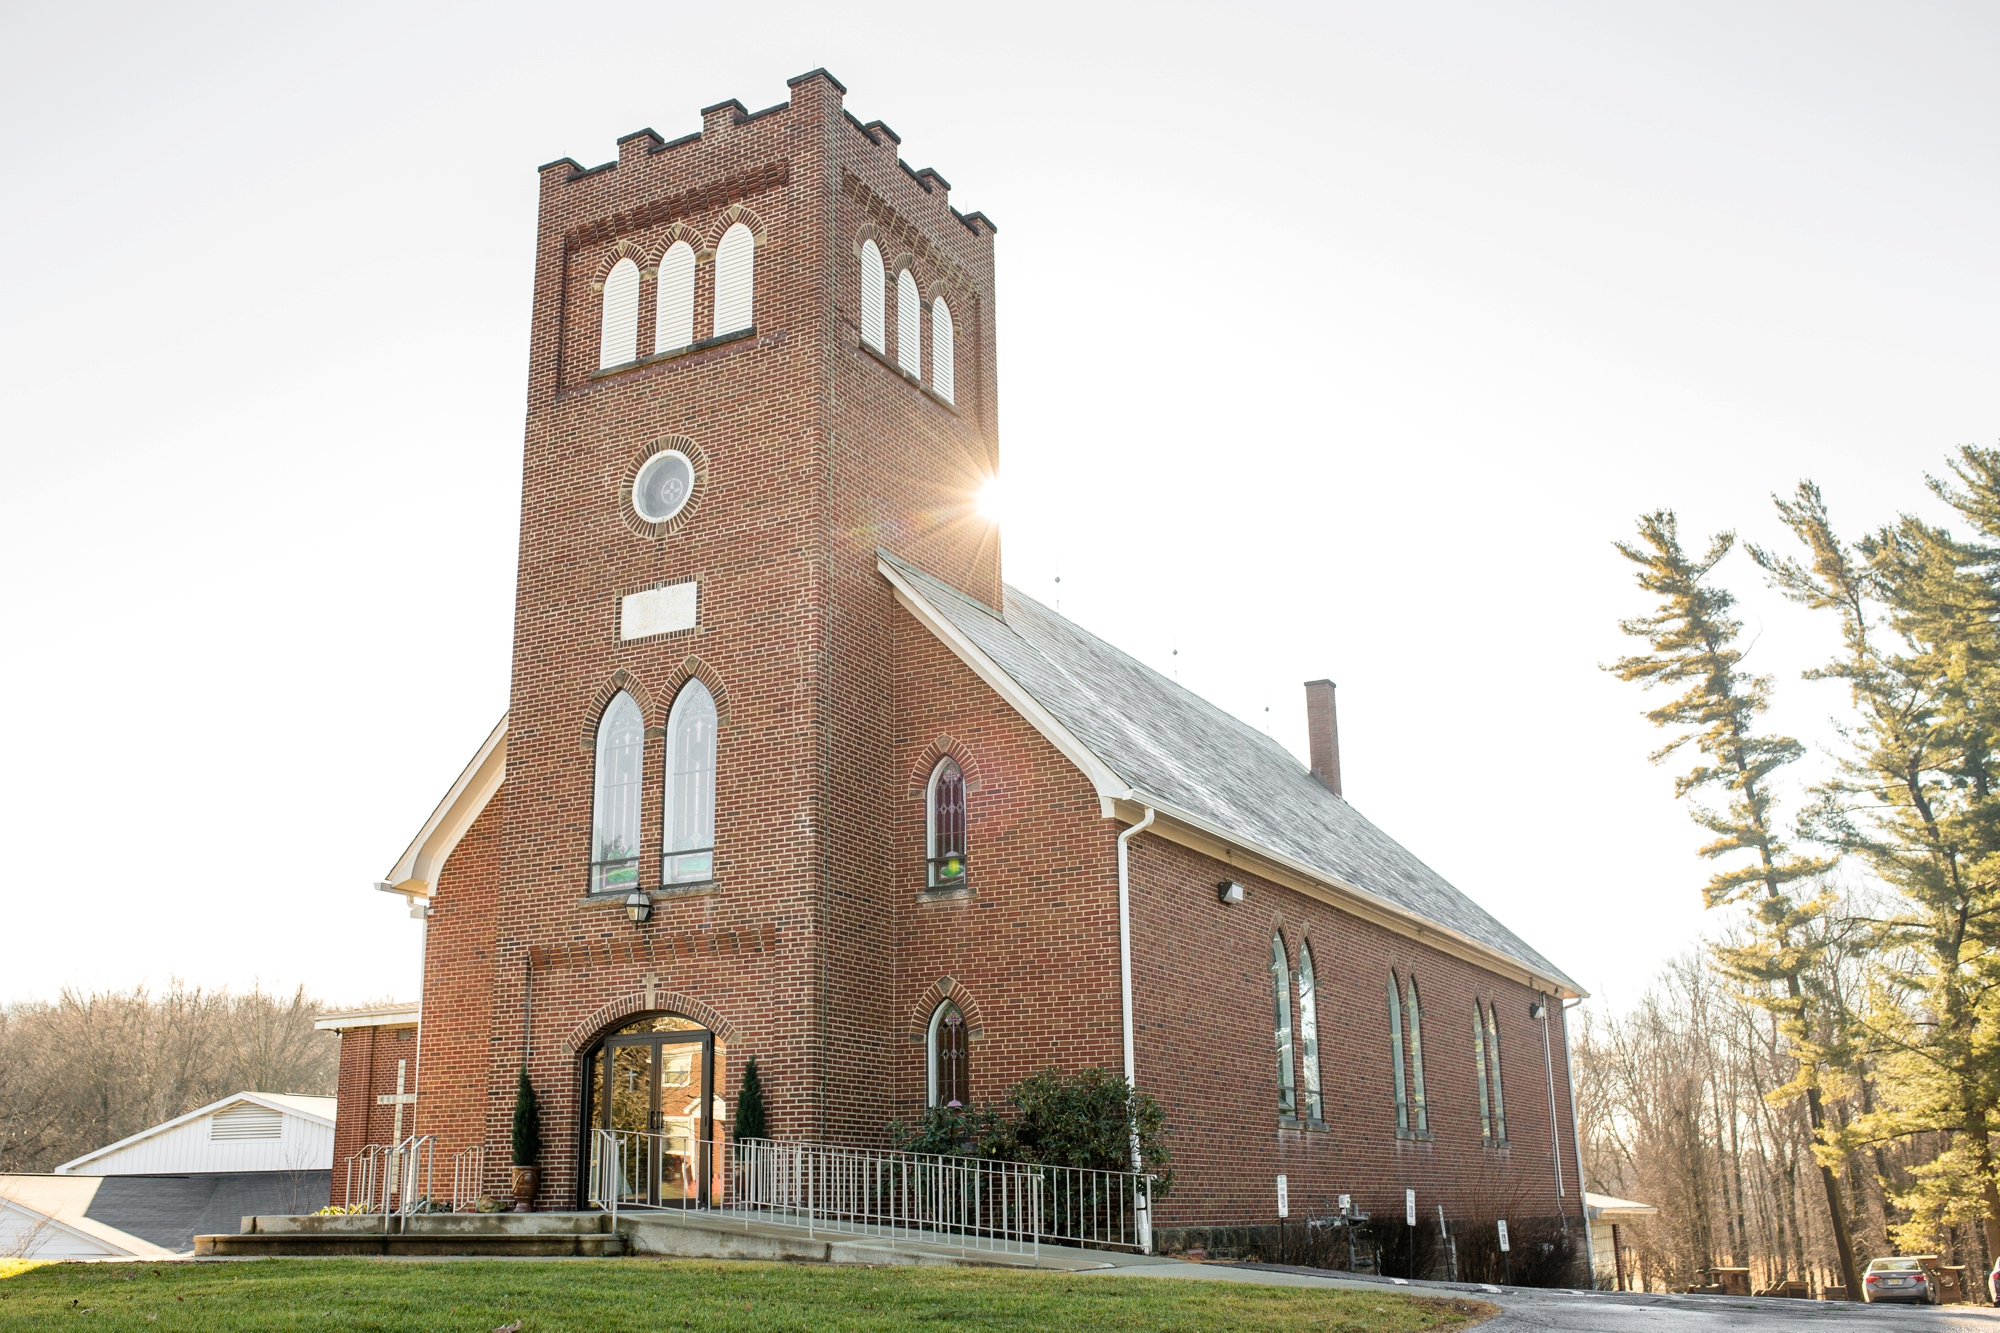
588,1129 -> 1152,1255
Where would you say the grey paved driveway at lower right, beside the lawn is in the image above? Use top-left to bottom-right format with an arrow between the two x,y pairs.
1210,1263 -> 2000,1333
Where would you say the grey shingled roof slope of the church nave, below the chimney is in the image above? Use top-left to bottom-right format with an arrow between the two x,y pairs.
876,550 -> 1584,995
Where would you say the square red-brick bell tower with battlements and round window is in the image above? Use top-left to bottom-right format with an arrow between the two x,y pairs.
474,70 -> 1000,1207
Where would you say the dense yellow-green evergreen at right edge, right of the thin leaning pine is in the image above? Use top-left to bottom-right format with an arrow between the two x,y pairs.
1752,464 -> 2000,1253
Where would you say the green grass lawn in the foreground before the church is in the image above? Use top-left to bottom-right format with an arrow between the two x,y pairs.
0,1259 -> 1490,1333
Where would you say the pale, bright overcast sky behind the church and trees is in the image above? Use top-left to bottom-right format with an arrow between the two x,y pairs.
0,0 -> 2000,1007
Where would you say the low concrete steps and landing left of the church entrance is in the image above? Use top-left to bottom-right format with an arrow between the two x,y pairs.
194,1213 -> 624,1259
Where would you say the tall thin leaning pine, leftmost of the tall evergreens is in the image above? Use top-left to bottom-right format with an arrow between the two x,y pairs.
1608,510 -> 1860,1299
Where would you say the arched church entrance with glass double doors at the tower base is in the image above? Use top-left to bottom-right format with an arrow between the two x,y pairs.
582,1015 -> 722,1207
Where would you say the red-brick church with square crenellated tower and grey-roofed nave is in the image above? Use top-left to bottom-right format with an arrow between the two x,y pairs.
324,70 -> 1582,1243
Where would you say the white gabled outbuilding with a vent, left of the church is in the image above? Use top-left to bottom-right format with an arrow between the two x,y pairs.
56,1093 -> 336,1175
